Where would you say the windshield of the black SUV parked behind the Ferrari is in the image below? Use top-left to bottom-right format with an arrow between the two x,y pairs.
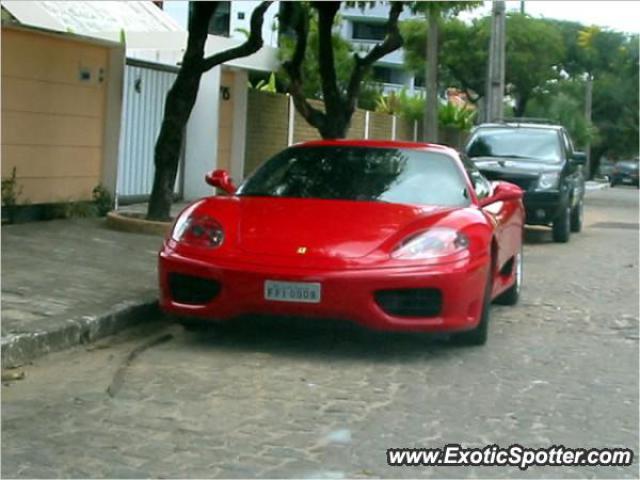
467,127 -> 562,163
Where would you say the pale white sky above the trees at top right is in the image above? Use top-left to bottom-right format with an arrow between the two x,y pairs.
464,0 -> 640,33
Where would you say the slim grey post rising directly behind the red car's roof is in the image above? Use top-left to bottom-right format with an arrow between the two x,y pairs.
423,9 -> 439,143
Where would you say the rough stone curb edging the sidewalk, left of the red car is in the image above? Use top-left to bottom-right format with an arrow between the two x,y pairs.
0,299 -> 160,368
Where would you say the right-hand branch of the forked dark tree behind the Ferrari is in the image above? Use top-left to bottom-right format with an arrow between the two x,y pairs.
346,1 -> 404,111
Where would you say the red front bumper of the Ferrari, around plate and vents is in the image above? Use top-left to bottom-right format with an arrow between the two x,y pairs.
158,249 -> 489,332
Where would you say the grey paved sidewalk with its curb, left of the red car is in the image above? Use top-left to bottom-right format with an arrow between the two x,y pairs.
1,219 -> 162,368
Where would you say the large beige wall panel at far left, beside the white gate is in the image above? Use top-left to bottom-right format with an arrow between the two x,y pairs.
1,26 -> 119,204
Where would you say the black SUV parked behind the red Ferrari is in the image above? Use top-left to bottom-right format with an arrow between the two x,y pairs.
465,120 -> 586,242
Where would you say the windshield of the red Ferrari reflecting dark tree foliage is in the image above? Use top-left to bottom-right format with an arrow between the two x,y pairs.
238,146 -> 469,206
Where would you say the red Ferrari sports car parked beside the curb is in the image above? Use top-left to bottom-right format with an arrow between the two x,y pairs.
159,140 -> 524,344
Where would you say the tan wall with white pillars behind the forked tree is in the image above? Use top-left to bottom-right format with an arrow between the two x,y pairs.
244,90 -> 414,177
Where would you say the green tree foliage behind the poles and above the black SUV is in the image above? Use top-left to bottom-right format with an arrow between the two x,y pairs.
401,13 -> 639,158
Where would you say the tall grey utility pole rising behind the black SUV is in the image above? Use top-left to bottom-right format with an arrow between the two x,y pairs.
485,1 -> 506,122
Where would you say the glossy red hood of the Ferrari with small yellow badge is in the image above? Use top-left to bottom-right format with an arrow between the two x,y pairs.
236,197 -> 451,259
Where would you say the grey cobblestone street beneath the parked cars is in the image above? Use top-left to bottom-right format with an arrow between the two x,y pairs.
2,188 -> 640,478
